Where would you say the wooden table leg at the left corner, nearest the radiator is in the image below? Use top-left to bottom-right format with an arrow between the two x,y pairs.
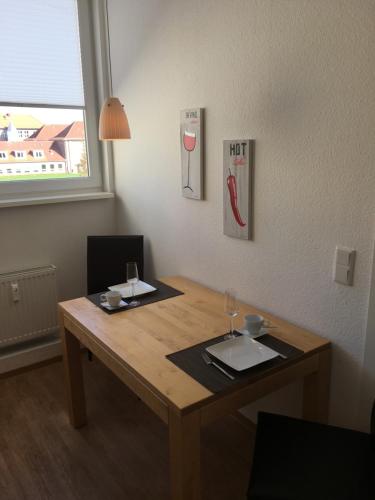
61,328 -> 86,428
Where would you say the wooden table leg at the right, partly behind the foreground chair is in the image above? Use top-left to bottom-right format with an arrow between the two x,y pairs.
302,349 -> 331,424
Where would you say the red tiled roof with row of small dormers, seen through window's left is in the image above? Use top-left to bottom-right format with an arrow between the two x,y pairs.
0,141 -> 65,163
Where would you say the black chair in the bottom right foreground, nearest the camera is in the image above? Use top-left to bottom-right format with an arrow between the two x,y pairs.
247,404 -> 375,500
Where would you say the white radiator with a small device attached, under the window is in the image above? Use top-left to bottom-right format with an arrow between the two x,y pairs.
0,265 -> 58,350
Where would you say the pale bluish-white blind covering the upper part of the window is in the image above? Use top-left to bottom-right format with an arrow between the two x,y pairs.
0,0 -> 84,106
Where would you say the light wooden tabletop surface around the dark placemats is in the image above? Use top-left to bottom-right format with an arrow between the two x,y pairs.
59,276 -> 329,411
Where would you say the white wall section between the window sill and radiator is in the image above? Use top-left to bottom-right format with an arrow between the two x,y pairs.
0,200 -> 115,300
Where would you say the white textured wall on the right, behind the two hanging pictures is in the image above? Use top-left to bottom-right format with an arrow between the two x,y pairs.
109,0 -> 375,426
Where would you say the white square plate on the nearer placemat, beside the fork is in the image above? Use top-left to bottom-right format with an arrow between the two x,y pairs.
206,335 -> 279,371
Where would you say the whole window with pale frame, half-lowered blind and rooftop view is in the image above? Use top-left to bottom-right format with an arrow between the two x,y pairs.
0,0 -> 108,203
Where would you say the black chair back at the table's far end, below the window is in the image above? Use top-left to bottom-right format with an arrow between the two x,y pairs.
87,235 -> 143,295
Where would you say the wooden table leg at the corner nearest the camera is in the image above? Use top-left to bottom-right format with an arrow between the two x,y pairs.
168,410 -> 201,500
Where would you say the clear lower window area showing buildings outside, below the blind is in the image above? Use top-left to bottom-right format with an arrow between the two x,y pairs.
0,106 -> 89,182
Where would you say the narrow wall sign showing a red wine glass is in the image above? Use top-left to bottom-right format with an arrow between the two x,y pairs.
180,108 -> 204,200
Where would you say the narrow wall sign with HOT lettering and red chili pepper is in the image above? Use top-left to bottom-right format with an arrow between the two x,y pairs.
223,140 -> 254,240
